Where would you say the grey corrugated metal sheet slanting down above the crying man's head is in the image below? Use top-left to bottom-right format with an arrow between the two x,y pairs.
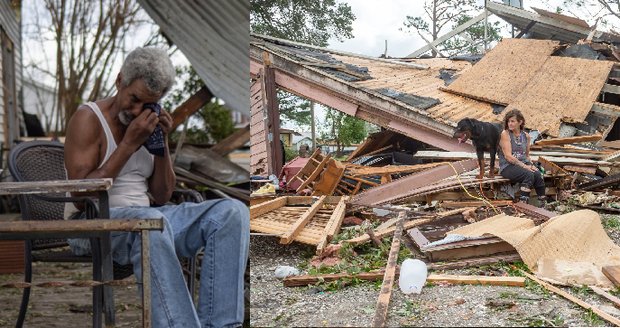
138,0 -> 250,115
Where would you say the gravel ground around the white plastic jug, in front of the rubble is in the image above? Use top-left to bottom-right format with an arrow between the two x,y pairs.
250,206 -> 620,327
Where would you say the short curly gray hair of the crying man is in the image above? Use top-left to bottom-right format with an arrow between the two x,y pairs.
121,47 -> 176,96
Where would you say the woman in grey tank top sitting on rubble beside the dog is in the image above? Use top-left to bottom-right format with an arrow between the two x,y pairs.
498,109 -> 547,205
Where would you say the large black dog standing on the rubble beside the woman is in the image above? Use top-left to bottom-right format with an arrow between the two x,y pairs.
453,118 -> 501,179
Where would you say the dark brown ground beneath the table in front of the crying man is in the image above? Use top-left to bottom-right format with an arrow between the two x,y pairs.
0,263 -> 142,328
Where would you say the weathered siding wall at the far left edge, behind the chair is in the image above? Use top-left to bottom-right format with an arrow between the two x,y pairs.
0,0 -> 22,152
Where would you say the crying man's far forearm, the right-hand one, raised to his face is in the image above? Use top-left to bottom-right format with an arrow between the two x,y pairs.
149,110 -> 176,204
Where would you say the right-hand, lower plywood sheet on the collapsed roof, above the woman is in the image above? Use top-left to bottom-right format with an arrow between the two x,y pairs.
506,57 -> 613,136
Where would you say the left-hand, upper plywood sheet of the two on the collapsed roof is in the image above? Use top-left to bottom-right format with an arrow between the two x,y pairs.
445,39 -> 559,105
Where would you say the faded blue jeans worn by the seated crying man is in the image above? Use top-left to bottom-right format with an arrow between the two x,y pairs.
72,199 -> 250,327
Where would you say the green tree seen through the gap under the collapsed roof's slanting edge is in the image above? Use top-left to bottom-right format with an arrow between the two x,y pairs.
321,109 -> 368,157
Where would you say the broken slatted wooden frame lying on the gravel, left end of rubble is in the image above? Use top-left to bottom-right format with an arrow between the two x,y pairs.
250,196 -> 348,253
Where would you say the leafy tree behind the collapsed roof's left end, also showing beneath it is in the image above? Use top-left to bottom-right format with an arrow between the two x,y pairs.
250,0 -> 355,126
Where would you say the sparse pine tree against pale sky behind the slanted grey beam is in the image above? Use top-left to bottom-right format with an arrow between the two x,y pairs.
401,0 -> 501,57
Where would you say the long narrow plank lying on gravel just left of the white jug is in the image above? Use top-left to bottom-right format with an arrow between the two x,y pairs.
373,212 -> 405,327
